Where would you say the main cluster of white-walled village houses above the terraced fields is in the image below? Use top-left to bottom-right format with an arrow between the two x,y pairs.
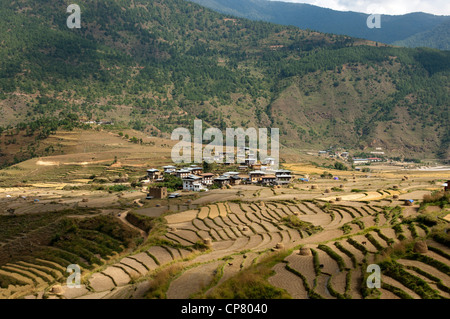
147,164 -> 293,192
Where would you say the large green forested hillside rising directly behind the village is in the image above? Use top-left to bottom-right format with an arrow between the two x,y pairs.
0,0 -> 450,165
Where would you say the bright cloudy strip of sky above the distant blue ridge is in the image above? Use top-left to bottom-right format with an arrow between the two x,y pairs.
272,0 -> 450,15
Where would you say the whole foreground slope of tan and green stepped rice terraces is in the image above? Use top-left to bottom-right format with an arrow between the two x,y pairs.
0,195 -> 450,299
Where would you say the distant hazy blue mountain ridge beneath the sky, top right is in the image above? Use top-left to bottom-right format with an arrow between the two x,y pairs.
190,0 -> 450,49
